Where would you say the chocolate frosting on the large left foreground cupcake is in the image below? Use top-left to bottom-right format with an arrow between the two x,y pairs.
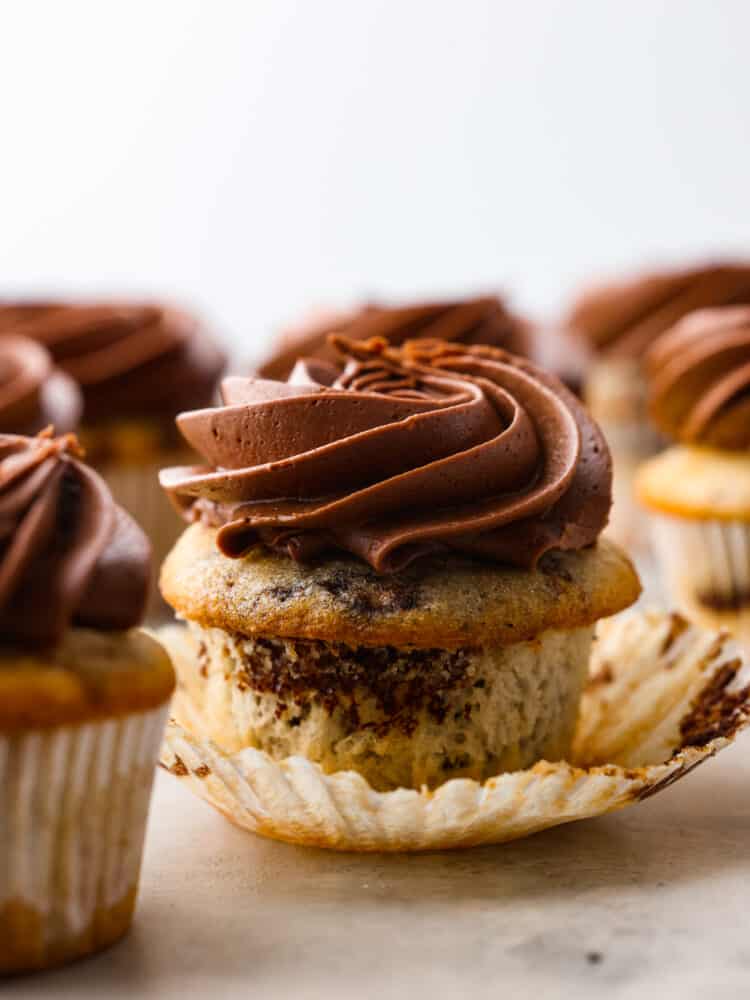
0,432 -> 151,647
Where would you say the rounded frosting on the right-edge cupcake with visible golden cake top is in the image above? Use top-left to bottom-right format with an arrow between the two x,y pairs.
646,306 -> 750,451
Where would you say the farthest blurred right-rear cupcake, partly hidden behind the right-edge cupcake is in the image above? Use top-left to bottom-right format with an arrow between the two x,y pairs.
566,263 -> 750,547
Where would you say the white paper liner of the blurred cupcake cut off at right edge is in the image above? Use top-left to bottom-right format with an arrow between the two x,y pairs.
650,514 -> 750,646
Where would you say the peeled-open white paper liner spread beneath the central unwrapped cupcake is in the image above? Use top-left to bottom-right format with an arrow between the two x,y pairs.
160,614 -> 750,851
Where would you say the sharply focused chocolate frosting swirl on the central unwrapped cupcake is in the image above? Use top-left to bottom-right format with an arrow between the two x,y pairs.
161,339 -> 611,573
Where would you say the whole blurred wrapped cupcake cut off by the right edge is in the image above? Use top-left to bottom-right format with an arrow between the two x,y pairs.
637,306 -> 750,641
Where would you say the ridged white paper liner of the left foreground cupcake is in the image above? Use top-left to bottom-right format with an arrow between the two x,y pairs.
0,705 -> 167,973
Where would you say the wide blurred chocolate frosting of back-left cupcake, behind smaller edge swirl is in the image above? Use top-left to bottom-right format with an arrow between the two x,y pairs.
0,302 -> 225,421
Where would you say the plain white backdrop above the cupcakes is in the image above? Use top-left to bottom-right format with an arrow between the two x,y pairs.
0,0 -> 750,357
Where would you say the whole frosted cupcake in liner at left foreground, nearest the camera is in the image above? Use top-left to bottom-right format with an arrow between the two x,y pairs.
0,434 -> 174,973
